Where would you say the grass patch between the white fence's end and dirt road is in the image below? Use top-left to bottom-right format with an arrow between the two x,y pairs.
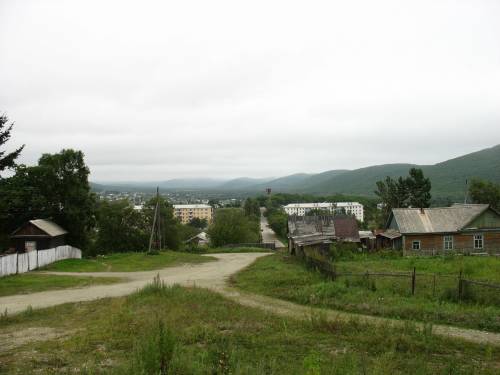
40,251 -> 215,272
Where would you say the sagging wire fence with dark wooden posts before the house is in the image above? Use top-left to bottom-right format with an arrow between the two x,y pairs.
304,255 -> 500,306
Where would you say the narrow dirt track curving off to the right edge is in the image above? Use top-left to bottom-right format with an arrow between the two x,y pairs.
217,287 -> 500,346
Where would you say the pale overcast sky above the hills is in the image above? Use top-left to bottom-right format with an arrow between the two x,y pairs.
0,0 -> 500,181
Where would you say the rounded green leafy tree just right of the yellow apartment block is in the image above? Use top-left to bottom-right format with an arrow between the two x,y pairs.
208,208 -> 260,247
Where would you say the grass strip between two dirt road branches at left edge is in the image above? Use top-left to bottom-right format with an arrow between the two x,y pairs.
0,273 -> 123,298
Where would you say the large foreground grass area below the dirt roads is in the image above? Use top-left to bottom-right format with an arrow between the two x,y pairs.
0,280 -> 500,375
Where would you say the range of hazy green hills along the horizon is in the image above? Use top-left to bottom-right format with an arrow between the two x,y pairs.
93,145 -> 500,199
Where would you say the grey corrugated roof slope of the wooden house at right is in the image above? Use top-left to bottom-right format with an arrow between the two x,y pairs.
392,204 -> 488,233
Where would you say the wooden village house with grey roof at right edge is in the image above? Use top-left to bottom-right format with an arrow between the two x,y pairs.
386,204 -> 500,255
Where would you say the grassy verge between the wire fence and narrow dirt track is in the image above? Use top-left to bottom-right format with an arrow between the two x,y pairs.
232,254 -> 500,332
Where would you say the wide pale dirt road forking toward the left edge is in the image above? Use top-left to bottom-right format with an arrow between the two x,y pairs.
0,253 -> 267,314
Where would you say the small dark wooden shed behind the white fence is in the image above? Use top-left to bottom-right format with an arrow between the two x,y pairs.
10,219 -> 68,253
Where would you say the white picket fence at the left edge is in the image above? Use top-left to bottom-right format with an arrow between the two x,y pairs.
0,245 -> 82,277
